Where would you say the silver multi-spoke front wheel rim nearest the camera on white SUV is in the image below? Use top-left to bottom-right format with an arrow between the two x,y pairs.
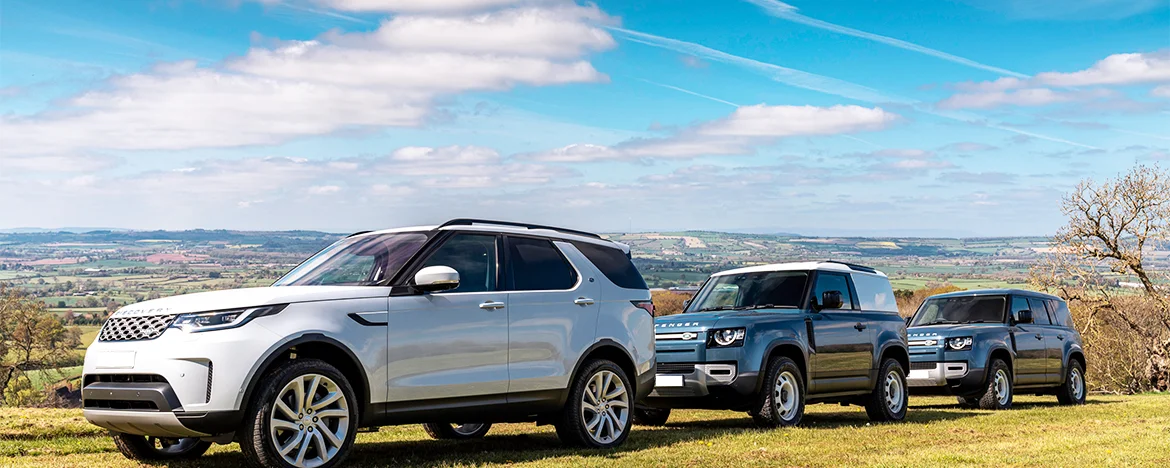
269,373 -> 350,468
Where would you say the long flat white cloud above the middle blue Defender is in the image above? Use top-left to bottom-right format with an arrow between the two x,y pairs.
523,104 -> 899,161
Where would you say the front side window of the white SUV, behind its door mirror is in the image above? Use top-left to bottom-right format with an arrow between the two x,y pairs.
422,234 -> 498,293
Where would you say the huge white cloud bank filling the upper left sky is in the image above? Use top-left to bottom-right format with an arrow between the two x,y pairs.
0,1 -> 613,154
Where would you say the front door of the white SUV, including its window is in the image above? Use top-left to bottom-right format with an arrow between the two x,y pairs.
386,234 -> 508,401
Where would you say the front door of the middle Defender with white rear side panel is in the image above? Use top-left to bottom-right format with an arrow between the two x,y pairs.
808,271 -> 873,393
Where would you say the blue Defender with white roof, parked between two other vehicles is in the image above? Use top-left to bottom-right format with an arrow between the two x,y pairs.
634,262 -> 910,427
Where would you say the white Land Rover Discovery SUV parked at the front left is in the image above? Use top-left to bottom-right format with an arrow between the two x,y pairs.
82,219 -> 655,467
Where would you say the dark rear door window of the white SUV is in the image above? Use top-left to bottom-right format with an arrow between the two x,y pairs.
508,238 -> 577,291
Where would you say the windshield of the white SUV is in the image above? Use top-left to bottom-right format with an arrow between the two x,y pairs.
273,233 -> 427,285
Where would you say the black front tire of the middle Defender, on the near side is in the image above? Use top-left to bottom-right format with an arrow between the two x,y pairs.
748,357 -> 805,428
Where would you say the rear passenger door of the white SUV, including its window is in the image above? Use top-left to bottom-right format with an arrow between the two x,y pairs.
504,236 -> 601,400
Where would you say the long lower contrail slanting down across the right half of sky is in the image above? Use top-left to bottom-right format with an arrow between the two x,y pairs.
607,27 -> 1099,150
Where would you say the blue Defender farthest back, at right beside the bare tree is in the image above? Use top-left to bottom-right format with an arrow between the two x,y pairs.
908,289 -> 1086,410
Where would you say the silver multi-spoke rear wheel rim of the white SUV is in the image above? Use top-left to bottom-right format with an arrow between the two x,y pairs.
581,371 -> 629,443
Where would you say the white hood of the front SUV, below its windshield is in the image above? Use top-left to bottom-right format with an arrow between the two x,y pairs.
111,285 -> 390,317
